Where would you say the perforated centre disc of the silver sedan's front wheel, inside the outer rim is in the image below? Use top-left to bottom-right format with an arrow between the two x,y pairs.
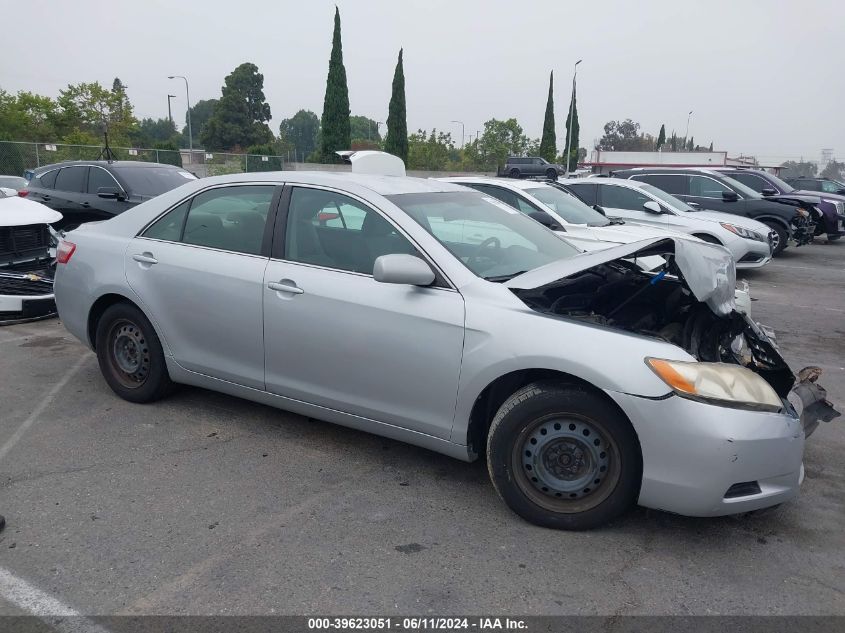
522,419 -> 610,499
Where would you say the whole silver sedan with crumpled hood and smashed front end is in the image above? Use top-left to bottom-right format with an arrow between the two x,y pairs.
55,172 -> 804,529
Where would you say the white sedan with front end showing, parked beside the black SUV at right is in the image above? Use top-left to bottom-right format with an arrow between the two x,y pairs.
561,178 -> 772,268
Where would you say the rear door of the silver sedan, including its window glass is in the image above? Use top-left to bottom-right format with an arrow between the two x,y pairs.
125,184 -> 281,389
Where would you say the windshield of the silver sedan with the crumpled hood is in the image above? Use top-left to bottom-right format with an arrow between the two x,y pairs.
387,191 -> 578,281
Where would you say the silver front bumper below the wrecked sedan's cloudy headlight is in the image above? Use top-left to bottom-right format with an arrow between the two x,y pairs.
607,391 -> 804,516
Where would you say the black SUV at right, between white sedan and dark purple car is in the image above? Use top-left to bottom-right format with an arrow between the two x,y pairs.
612,167 -> 818,255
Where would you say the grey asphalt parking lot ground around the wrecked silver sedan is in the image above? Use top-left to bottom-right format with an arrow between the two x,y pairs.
0,243 -> 845,615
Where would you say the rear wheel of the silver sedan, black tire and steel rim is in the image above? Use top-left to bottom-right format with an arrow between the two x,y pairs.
96,303 -> 173,402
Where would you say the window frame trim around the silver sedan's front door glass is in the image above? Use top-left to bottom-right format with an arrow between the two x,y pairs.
270,182 -> 457,292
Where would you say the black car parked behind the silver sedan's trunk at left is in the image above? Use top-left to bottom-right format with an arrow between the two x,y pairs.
18,161 -> 196,230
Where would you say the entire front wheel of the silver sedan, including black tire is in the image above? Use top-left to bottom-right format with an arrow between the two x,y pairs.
487,382 -> 642,530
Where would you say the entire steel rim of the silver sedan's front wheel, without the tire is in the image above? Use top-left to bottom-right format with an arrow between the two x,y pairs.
512,416 -> 620,513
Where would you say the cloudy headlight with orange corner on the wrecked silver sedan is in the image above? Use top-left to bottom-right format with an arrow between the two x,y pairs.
646,358 -> 783,411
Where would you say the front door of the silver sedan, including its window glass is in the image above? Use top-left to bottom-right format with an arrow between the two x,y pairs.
263,187 -> 464,438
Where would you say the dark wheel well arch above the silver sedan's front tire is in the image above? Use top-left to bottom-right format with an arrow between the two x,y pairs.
467,369 -> 636,455
